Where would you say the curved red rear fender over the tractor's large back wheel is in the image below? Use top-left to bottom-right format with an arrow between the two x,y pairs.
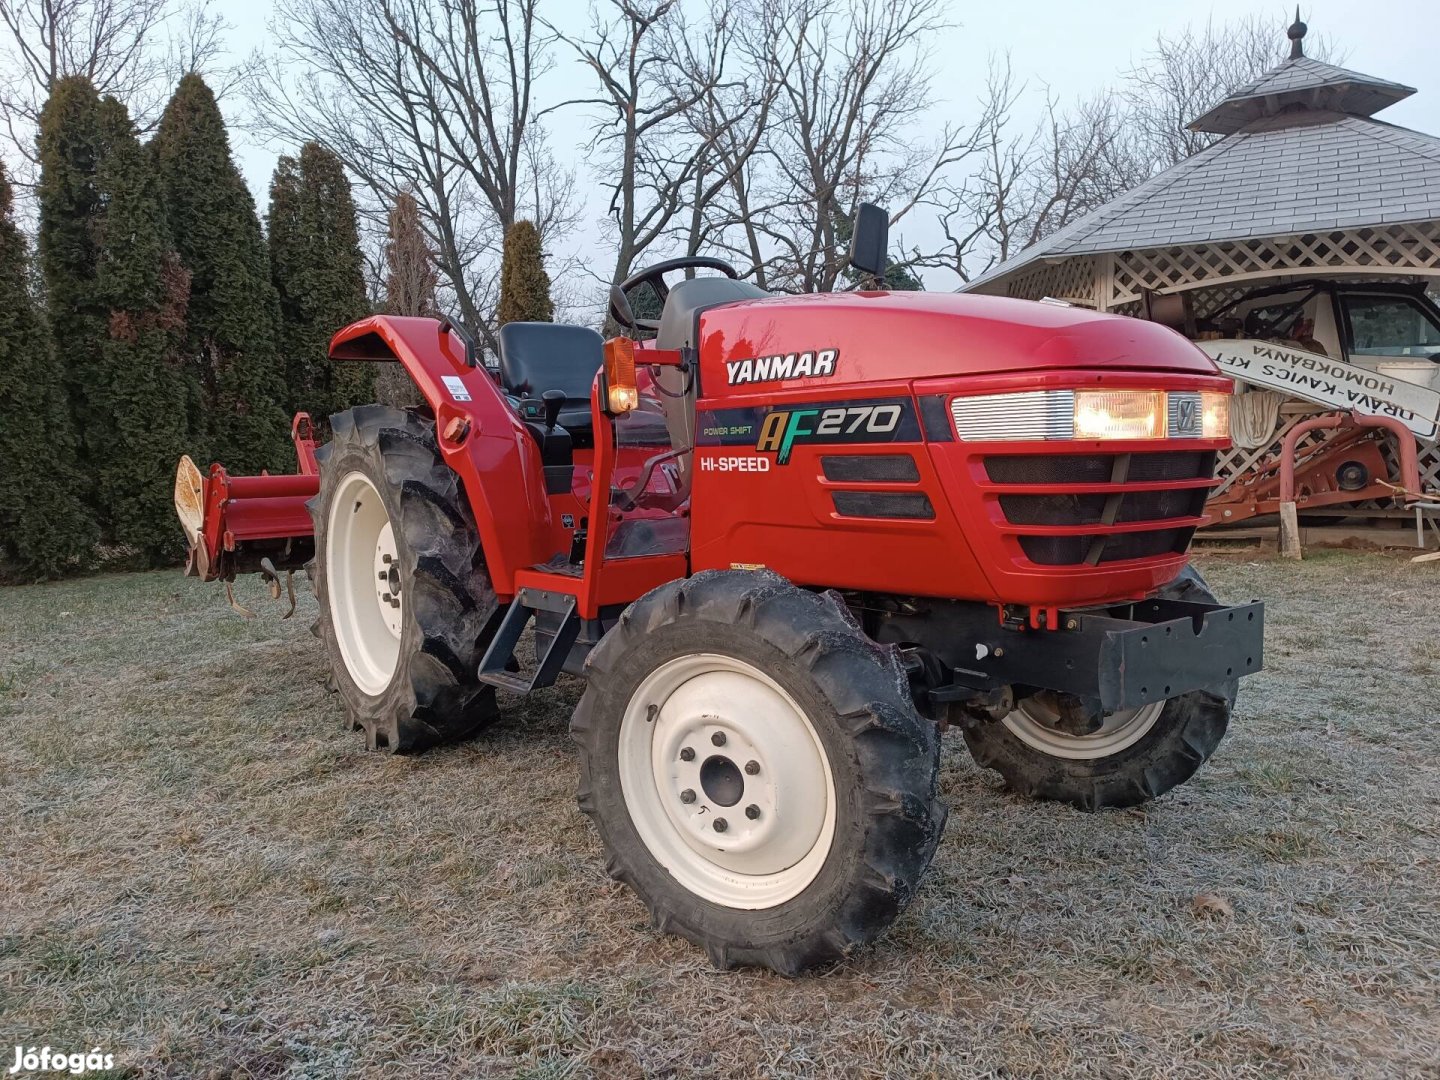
330,315 -> 552,599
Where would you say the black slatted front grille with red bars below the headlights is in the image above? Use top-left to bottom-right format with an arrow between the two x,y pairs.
985,451 -> 1215,566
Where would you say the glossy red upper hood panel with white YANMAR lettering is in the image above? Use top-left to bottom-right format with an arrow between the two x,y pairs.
700,292 -> 1217,396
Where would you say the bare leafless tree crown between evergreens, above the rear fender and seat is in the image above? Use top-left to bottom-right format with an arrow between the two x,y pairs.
246,0 -> 577,347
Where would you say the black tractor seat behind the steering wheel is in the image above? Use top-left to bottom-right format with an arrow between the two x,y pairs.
500,323 -> 605,445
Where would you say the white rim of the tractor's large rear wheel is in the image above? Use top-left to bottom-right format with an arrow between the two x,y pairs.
325,472 -> 405,697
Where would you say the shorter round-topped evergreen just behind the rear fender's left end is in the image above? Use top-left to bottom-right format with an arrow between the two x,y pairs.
269,143 -> 374,418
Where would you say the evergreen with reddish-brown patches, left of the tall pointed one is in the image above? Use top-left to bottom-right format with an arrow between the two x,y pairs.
94,98 -> 199,564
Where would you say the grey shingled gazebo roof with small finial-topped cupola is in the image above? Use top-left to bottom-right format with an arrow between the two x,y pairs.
963,22 -> 1440,292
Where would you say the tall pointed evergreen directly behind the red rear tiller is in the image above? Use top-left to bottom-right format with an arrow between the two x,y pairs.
151,72 -> 294,472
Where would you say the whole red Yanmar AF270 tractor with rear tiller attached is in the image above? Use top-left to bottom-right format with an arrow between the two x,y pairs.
177,208 -> 1263,972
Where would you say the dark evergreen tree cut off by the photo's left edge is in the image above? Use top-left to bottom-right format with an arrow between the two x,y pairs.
0,163 -> 95,580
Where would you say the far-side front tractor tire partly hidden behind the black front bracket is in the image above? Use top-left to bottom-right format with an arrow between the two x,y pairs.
963,566 -> 1238,811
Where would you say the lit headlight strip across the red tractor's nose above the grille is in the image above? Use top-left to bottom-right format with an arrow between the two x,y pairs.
950,390 -> 1230,442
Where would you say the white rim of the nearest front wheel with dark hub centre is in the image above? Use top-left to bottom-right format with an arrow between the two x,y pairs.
618,652 -> 835,910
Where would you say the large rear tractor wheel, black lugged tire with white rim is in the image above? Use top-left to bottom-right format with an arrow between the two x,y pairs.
307,405 -> 497,753
